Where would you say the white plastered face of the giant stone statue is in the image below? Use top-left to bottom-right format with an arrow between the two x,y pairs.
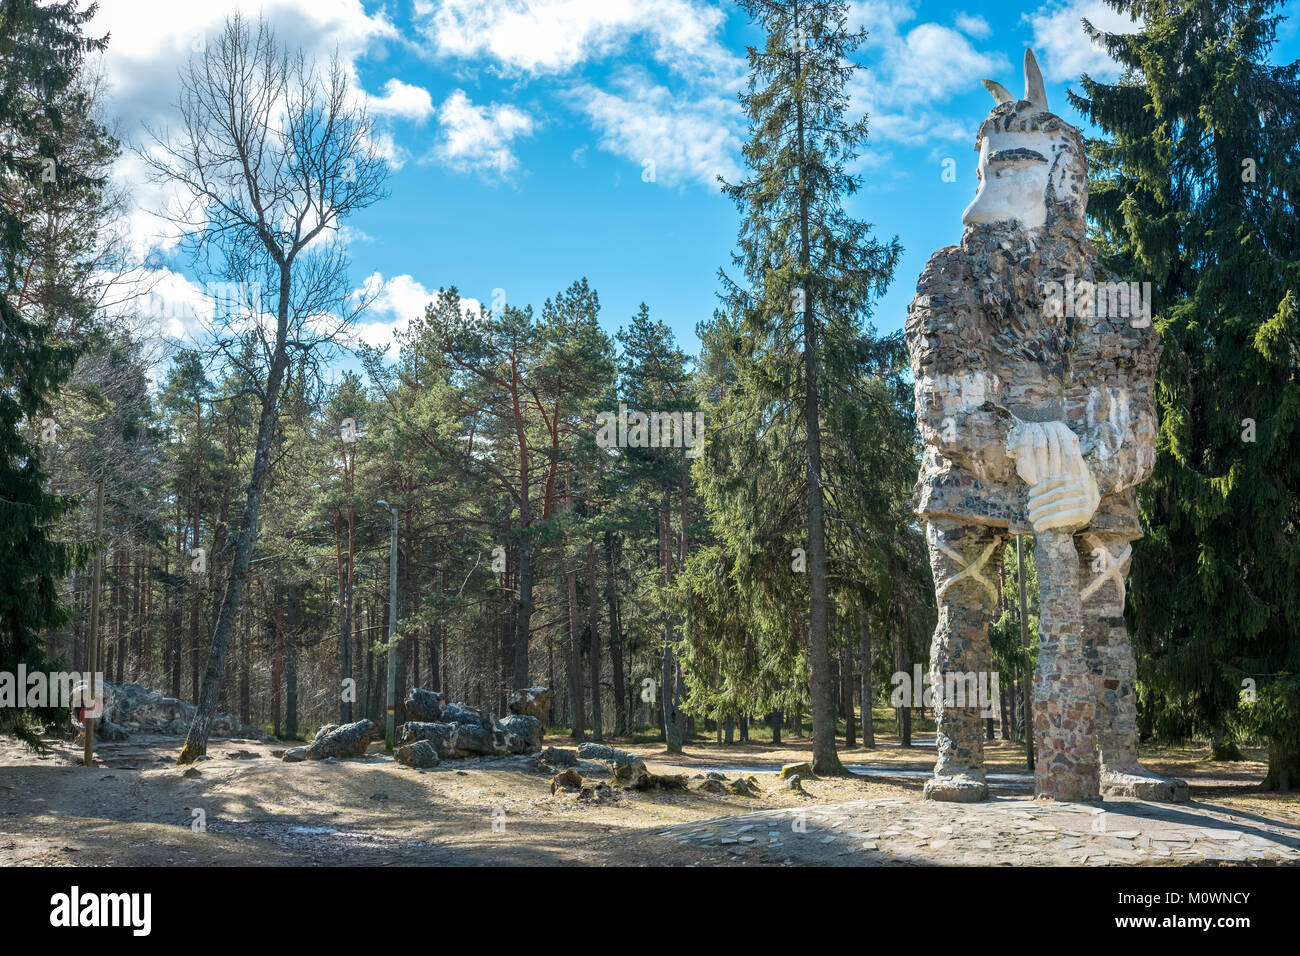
962,124 -> 1061,229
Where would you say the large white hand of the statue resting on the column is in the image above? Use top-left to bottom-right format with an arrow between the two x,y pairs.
1006,421 -> 1101,531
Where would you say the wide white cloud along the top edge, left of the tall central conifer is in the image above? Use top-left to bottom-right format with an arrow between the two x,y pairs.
415,0 -> 731,75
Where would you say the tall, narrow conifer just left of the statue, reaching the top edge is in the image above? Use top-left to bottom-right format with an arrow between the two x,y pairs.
706,0 -> 898,773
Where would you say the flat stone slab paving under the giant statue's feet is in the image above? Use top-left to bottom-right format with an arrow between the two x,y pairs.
659,797 -> 1300,866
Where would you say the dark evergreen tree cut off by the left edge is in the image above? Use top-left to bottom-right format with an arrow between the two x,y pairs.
0,0 -> 116,744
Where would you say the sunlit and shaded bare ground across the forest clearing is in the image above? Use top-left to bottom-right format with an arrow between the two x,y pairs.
0,735 -> 1300,866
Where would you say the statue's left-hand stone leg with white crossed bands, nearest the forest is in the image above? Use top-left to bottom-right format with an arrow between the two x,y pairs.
924,518 -> 1001,803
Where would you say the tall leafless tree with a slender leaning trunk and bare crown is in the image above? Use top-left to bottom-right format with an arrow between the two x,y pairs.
142,14 -> 387,763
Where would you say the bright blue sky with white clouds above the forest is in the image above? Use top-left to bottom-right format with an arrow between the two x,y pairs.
99,0 -> 1300,361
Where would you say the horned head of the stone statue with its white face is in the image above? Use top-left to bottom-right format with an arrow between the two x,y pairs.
962,49 -> 1088,232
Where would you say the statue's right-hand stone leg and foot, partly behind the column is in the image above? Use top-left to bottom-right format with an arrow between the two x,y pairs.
1078,531 -> 1187,803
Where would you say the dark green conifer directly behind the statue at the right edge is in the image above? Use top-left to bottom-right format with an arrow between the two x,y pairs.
1071,0 -> 1300,790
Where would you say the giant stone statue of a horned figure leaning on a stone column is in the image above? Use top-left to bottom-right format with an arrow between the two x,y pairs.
906,51 -> 1187,801
